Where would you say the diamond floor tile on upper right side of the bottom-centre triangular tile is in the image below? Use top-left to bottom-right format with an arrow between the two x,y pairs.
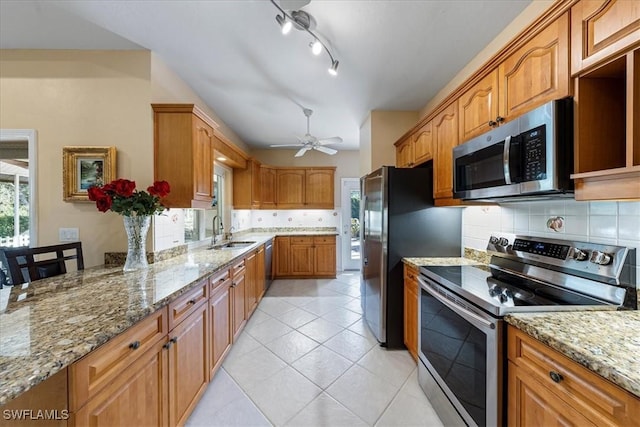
326,365 -> 399,425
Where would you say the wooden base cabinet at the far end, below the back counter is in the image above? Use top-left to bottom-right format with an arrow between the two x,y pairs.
274,236 -> 336,278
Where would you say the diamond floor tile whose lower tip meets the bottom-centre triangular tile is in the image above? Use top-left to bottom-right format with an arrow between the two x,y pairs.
292,346 -> 353,389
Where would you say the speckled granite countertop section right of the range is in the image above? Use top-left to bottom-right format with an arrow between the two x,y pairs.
505,310 -> 640,397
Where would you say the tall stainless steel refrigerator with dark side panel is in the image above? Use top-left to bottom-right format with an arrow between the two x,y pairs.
360,162 -> 462,348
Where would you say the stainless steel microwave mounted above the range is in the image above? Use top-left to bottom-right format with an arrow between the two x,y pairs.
453,98 -> 573,201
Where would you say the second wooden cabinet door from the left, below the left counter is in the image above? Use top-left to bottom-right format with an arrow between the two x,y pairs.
168,304 -> 209,426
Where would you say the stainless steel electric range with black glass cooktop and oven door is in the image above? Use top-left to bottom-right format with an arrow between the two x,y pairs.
418,236 -> 638,426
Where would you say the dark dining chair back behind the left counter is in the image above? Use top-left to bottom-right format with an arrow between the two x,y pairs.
2,242 -> 84,285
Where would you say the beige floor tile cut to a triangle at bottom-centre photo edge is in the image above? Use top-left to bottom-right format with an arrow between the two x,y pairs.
287,393 -> 367,427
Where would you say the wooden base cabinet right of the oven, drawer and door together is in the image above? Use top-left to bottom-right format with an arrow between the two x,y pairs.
507,326 -> 640,426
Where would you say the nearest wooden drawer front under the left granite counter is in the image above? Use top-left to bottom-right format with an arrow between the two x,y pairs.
69,308 -> 168,411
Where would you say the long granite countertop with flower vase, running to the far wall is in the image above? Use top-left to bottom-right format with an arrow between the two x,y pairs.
0,230 -> 337,405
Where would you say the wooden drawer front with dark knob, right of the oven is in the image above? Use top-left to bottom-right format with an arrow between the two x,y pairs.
508,327 -> 640,425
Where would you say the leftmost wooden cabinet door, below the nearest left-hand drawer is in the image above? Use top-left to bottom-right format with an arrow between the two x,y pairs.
70,341 -> 169,426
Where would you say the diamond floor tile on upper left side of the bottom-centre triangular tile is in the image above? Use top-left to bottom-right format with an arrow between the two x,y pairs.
246,367 -> 322,426
